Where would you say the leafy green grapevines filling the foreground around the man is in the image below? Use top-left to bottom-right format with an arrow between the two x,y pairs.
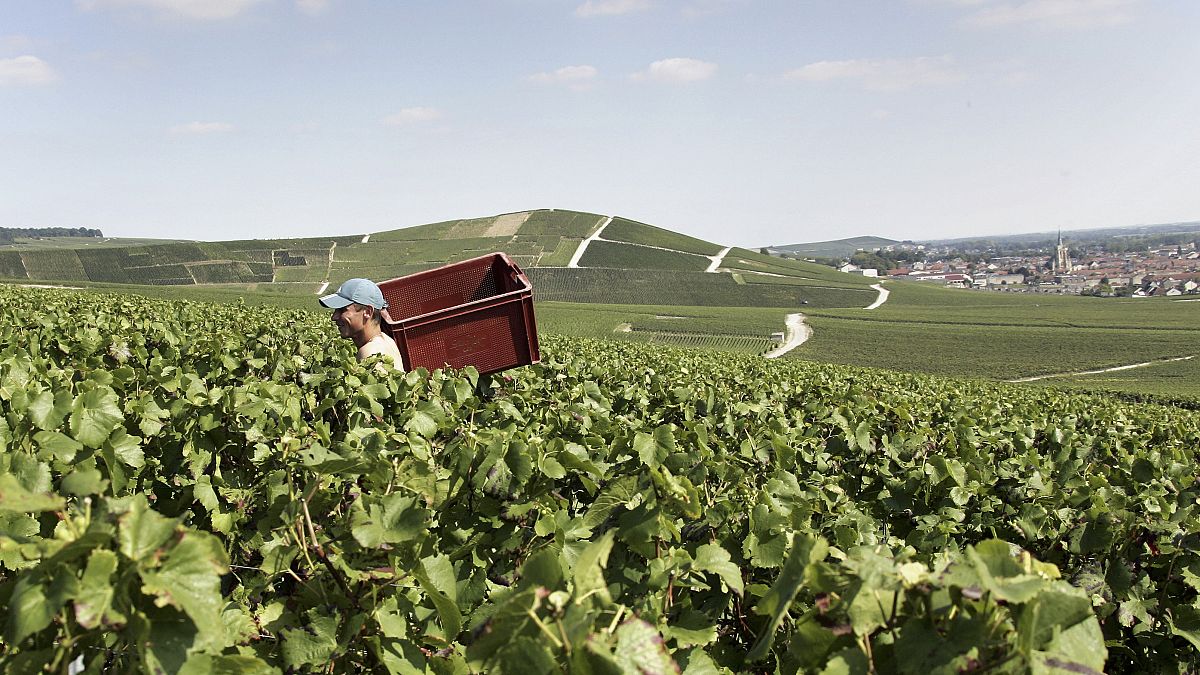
0,286 -> 1200,675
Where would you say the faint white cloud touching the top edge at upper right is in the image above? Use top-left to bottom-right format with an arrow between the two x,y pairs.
964,0 -> 1138,29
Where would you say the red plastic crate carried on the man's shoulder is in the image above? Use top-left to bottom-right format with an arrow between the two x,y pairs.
379,253 -> 541,375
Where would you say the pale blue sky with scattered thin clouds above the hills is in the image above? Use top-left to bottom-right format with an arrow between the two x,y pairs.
0,0 -> 1200,246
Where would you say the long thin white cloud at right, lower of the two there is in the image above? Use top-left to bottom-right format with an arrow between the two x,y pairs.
784,56 -> 962,91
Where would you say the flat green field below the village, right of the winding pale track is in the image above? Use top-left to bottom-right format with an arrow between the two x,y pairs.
793,278 -> 1200,396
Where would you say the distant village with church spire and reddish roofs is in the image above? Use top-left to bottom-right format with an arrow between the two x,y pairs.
772,237 -> 1200,298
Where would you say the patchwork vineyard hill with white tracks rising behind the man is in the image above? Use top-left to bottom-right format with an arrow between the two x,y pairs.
0,209 -> 874,307
